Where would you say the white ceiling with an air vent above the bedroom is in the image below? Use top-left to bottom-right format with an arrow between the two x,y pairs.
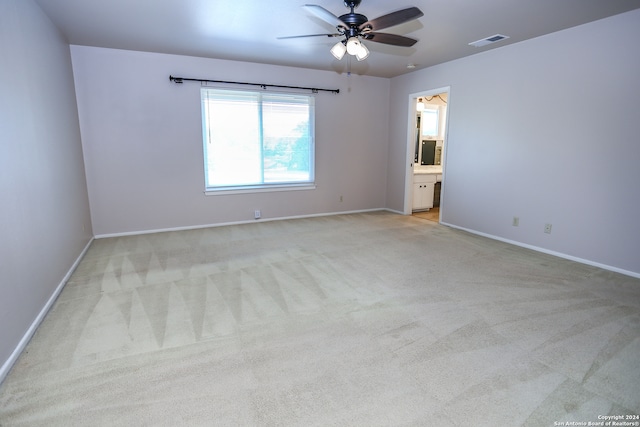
35,0 -> 640,77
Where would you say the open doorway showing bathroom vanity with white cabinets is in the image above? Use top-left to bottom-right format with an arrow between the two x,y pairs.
404,87 -> 450,222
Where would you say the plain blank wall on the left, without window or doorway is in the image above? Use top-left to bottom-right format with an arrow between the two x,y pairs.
0,0 -> 91,380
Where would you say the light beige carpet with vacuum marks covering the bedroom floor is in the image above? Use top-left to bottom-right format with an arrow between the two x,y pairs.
0,212 -> 640,426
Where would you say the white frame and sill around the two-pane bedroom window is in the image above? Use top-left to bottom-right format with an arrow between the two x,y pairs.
200,86 -> 316,195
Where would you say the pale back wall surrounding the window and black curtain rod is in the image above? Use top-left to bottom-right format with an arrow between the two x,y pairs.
71,46 -> 390,236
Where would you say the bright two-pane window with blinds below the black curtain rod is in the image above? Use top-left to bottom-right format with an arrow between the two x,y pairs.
201,88 -> 314,192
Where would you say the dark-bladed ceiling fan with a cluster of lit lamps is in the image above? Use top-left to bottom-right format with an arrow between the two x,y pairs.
278,0 -> 424,61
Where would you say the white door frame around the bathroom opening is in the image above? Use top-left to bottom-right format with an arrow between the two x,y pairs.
404,86 -> 451,222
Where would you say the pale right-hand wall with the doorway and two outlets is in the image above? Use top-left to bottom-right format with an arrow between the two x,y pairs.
387,10 -> 640,275
